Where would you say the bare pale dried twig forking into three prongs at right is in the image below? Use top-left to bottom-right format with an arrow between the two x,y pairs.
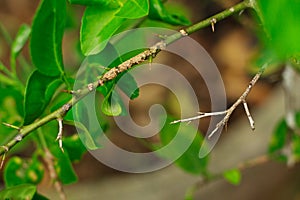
171,64 -> 268,139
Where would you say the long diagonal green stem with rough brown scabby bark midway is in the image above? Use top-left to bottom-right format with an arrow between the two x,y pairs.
0,0 -> 252,155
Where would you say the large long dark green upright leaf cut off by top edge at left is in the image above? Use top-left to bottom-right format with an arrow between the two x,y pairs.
30,0 -> 66,76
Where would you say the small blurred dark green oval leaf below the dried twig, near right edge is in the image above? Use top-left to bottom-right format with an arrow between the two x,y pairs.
268,120 -> 288,154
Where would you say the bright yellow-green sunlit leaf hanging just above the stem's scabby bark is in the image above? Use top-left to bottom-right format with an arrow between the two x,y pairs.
80,6 -> 124,56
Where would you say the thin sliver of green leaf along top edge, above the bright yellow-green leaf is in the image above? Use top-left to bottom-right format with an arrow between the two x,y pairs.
68,0 -> 120,8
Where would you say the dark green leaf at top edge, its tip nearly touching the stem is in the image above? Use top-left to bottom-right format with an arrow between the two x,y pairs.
149,0 -> 191,26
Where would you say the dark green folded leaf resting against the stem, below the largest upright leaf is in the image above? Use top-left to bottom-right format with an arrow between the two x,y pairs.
24,70 -> 61,125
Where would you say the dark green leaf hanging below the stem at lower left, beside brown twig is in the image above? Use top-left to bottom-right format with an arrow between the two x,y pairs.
49,144 -> 77,184
